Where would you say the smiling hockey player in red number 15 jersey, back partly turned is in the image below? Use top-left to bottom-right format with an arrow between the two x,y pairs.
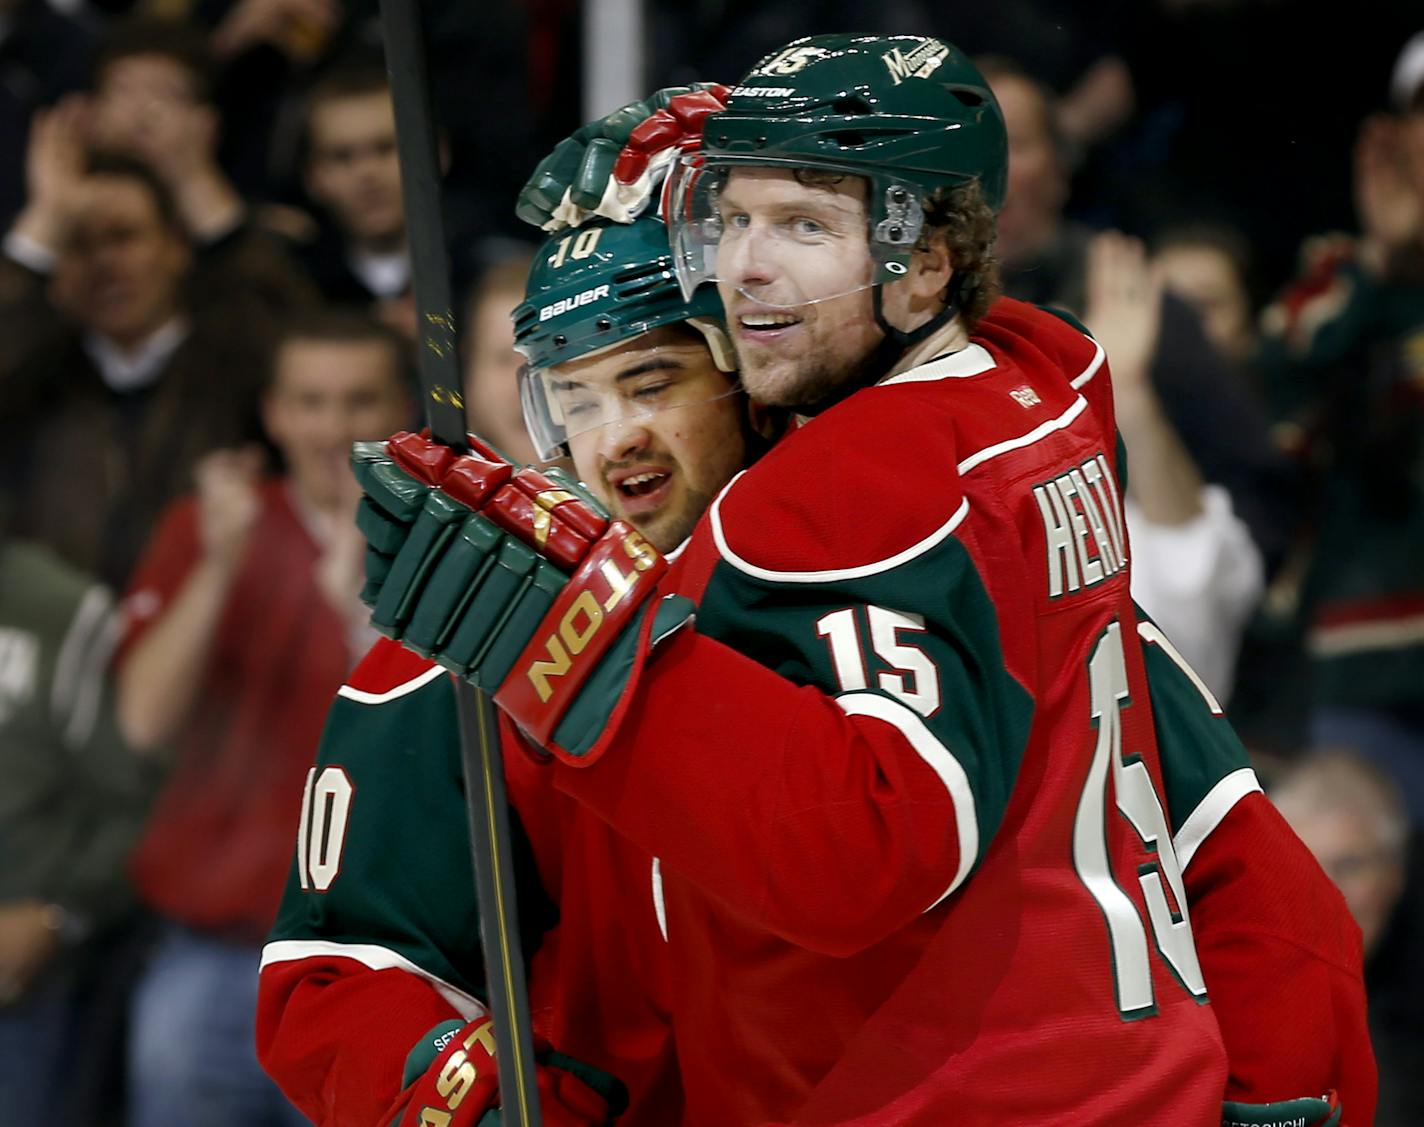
262,37 -> 1373,1123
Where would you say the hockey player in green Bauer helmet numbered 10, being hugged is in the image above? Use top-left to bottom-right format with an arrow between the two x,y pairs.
258,218 -> 770,1127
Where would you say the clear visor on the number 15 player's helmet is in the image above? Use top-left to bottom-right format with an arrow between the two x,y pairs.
664,152 -> 924,309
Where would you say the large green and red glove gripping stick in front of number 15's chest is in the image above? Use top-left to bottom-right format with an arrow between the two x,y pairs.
353,433 -> 691,762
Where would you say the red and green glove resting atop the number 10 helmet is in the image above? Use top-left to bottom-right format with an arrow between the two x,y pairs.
515,83 -> 729,231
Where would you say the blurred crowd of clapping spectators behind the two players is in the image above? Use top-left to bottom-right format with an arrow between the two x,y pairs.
0,0 -> 1424,1127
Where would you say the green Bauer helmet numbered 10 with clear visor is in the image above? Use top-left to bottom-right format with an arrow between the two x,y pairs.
513,217 -> 739,459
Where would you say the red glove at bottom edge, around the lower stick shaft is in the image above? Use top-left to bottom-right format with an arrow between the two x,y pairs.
387,1016 -> 628,1127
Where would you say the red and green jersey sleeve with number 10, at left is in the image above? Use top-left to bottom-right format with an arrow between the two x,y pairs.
258,641 -> 550,1124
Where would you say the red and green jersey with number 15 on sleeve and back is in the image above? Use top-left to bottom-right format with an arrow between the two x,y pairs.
555,308 -> 1226,1124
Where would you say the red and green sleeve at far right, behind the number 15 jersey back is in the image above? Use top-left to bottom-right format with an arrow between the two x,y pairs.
1138,617 -> 1376,1123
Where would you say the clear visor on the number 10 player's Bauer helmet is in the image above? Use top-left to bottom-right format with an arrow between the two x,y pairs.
520,341 -> 742,460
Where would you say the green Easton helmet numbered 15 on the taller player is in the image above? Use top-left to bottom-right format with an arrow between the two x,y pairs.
665,34 -> 1008,302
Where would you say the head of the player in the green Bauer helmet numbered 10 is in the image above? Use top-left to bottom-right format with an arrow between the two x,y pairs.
514,219 -> 770,551
